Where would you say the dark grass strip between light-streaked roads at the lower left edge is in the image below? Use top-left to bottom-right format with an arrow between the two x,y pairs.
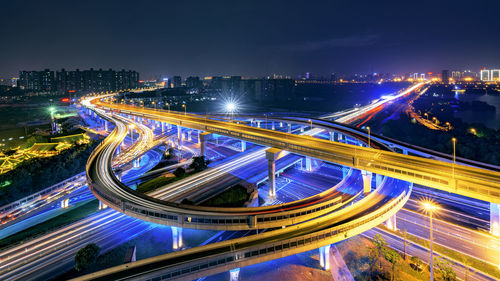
0,200 -> 99,249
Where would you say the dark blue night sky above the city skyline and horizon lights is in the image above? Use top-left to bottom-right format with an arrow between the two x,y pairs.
0,0 -> 500,79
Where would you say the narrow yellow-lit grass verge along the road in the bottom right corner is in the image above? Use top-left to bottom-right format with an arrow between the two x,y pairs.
378,225 -> 500,280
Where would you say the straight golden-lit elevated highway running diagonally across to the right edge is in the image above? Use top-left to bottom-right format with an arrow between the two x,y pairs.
93,99 -> 500,203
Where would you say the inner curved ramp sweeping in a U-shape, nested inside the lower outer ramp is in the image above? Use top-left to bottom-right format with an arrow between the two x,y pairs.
87,101 -> 378,230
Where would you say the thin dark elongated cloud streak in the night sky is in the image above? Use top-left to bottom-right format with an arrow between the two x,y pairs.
281,34 -> 379,52
